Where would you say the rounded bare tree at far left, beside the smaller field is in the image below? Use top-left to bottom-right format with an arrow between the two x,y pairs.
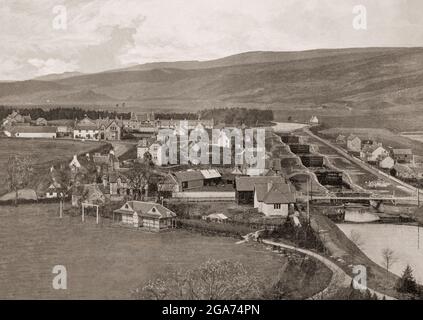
7,155 -> 32,206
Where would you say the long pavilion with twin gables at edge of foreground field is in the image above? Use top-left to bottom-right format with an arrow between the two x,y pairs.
113,201 -> 176,232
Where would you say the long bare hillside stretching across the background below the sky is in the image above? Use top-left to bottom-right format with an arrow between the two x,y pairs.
0,48 -> 423,112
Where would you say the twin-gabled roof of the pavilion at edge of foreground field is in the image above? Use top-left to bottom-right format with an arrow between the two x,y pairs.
115,201 -> 176,219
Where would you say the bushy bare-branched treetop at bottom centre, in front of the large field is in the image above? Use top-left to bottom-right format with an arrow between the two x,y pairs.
133,260 -> 262,300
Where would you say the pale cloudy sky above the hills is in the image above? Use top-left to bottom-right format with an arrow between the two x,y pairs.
0,0 -> 423,80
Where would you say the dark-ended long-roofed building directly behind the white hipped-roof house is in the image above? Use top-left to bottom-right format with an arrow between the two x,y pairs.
235,176 -> 285,204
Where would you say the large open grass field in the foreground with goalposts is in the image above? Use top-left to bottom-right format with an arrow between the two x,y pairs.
0,204 -> 330,299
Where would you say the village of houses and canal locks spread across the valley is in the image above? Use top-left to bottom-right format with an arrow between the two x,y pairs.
0,111 -> 423,235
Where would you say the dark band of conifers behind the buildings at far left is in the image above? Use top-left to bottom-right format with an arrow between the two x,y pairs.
0,106 -> 131,120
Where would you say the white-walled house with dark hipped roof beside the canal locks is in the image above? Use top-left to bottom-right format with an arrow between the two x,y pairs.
254,181 -> 296,217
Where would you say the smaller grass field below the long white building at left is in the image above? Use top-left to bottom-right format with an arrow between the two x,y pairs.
0,138 -> 104,195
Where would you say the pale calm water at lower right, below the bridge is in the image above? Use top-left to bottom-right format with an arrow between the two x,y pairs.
338,224 -> 423,284
